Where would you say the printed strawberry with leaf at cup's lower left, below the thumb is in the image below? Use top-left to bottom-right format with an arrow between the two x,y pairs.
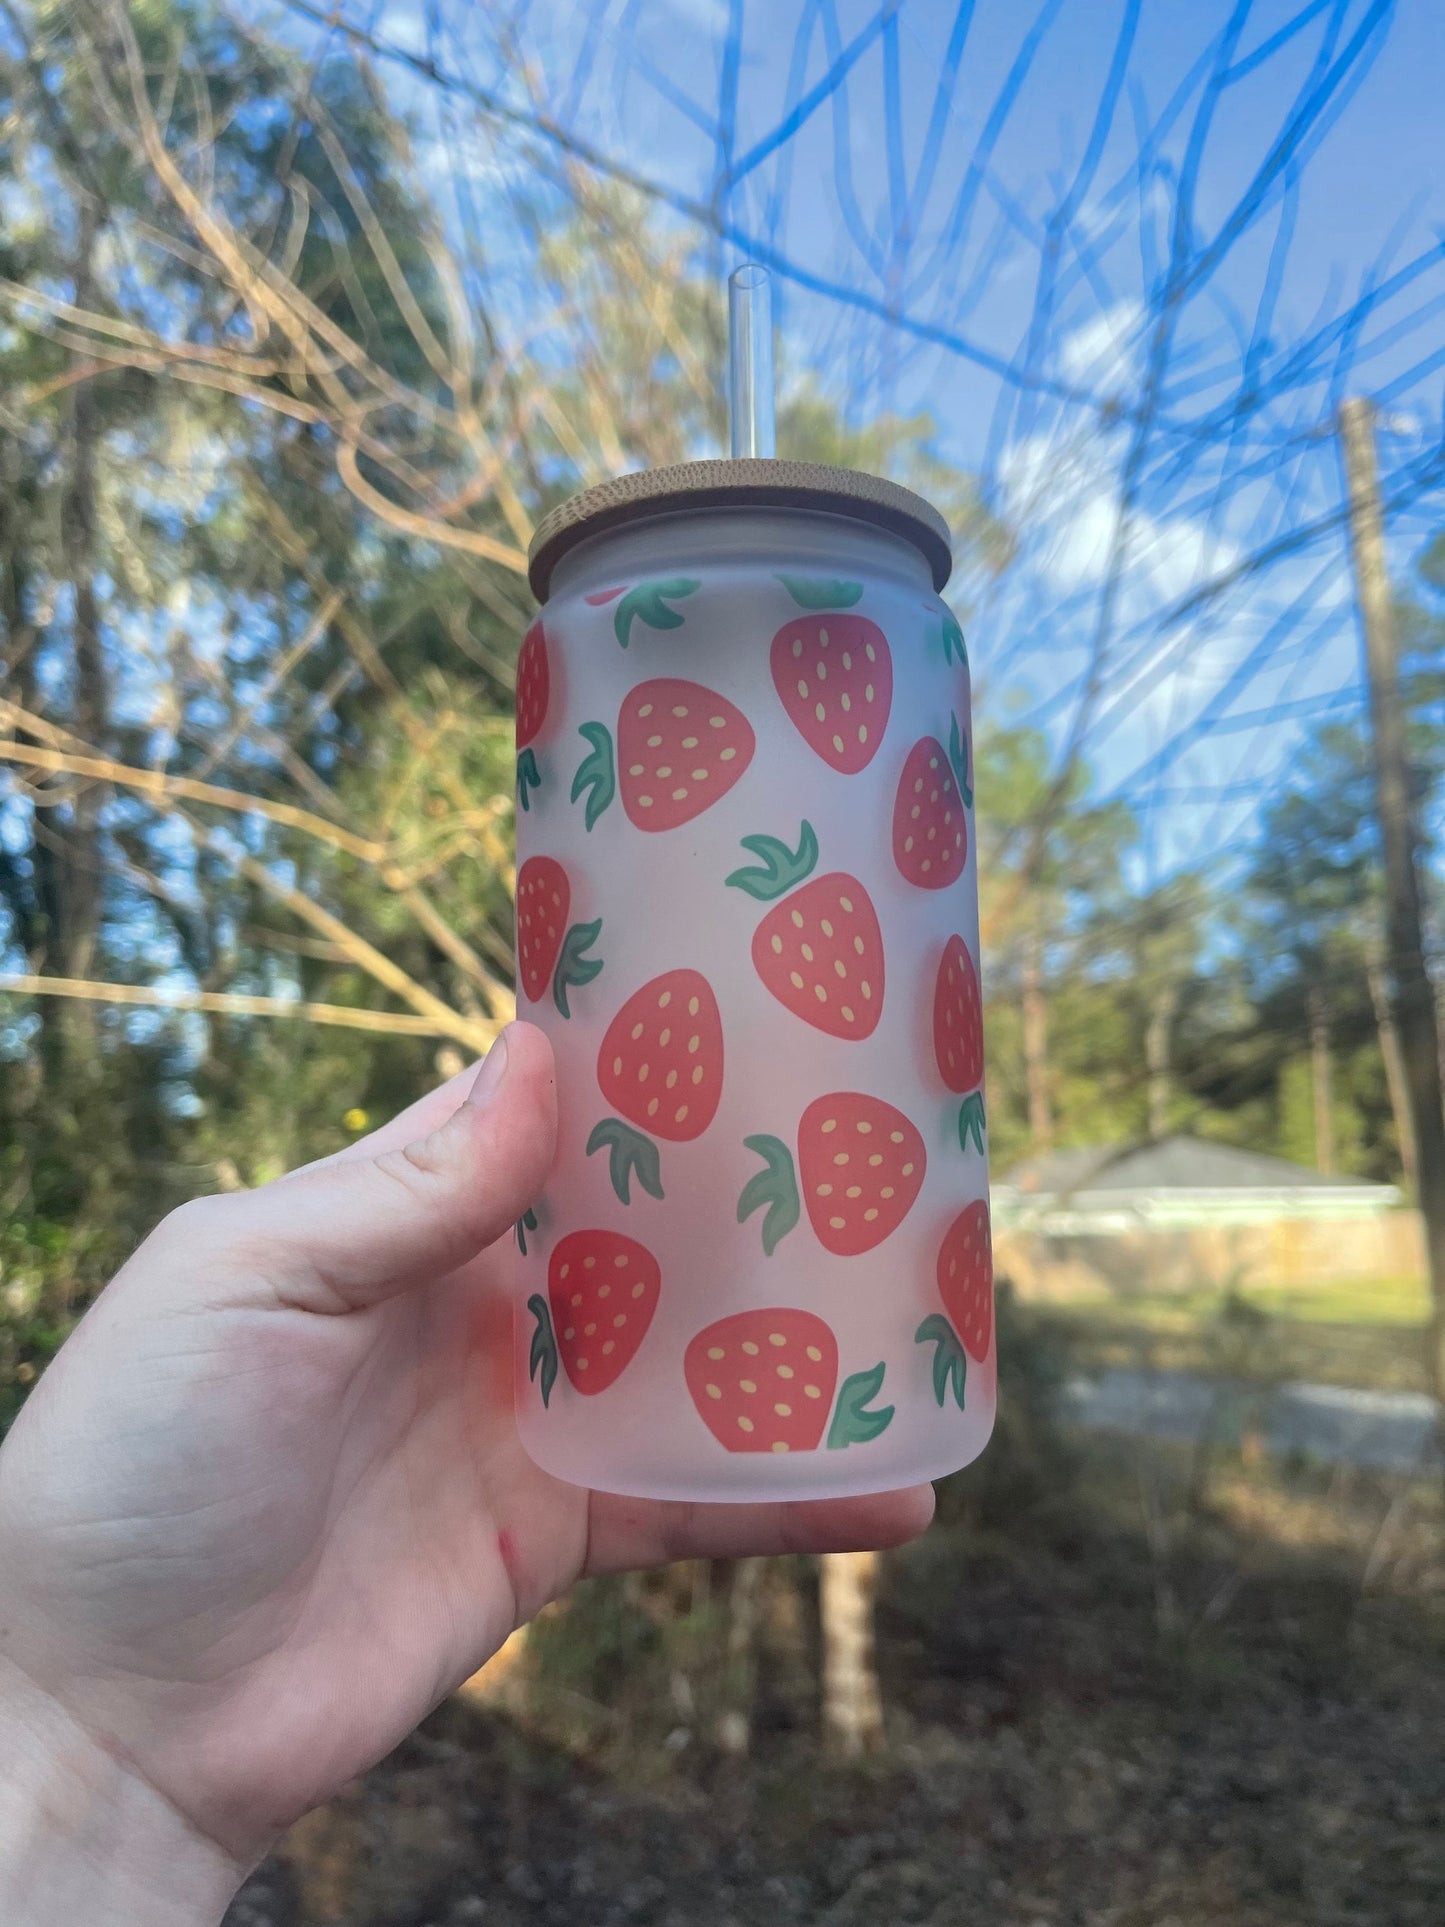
526,1229 -> 663,1405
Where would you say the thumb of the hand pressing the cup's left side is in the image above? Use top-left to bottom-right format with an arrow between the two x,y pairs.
192,1023 -> 557,1312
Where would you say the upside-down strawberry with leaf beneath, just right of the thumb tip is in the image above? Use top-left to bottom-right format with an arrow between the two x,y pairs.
588,969 -> 723,1204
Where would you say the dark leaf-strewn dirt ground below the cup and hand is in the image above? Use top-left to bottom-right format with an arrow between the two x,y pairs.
227,1443 -> 1445,1927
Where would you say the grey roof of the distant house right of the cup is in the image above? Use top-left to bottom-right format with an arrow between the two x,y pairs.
998,1137 -> 1393,1201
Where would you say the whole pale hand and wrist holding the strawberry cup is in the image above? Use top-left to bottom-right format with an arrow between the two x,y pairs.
0,1023 -> 933,1927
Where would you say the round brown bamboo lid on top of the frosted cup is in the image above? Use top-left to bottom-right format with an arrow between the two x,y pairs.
528,461 -> 954,603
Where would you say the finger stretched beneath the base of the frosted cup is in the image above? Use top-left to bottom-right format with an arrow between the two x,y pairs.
588,1486 -> 933,1572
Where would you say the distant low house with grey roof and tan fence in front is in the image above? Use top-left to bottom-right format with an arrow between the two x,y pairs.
992,1137 -> 1424,1297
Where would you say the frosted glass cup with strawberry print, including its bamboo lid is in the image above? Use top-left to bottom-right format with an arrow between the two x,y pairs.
516,461 -> 996,1499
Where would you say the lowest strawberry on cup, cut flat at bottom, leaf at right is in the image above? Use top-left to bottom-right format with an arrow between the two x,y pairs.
682,1307 -> 894,1453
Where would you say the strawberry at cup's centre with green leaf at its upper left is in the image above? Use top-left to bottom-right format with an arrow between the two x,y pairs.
728,823 -> 882,1039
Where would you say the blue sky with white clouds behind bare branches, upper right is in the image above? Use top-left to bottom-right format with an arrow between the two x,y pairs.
321,0 -> 1445,873
